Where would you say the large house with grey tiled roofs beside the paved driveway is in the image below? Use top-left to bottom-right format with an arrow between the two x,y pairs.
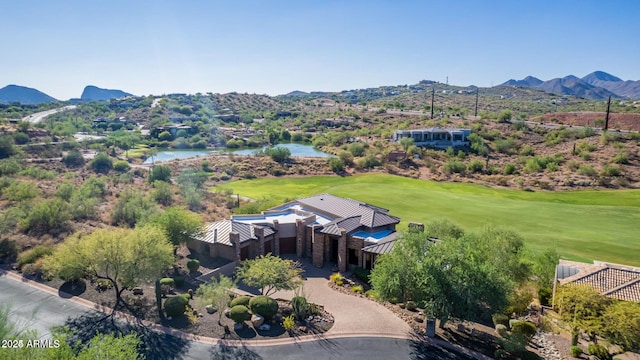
188,194 -> 400,271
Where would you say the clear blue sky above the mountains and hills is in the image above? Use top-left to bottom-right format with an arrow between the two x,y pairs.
0,0 -> 640,100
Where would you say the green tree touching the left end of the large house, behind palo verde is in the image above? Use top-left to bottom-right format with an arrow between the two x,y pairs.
151,206 -> 204,249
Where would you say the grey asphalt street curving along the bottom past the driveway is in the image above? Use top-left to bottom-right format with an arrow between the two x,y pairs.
0,274 -> 470,360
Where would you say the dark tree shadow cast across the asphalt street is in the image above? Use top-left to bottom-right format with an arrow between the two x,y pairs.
59,313 -> 189,360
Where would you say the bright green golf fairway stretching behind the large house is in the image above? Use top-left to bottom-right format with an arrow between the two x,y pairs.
215,174 -> 640,266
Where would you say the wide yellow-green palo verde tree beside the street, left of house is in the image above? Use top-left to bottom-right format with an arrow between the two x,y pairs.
45,226 -> 175,311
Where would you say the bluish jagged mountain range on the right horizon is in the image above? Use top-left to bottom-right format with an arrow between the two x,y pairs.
499,71 -> 640,100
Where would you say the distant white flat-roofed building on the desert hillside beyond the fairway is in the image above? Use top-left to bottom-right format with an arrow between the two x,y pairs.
392,127 -> 471,148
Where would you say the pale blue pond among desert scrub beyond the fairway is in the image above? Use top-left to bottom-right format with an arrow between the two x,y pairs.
144,143 -> 331,164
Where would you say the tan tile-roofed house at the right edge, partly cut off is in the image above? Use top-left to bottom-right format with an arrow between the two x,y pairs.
554,260 -> 640,302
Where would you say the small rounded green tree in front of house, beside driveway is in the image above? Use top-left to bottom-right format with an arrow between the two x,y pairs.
236,254 -> 302,295
